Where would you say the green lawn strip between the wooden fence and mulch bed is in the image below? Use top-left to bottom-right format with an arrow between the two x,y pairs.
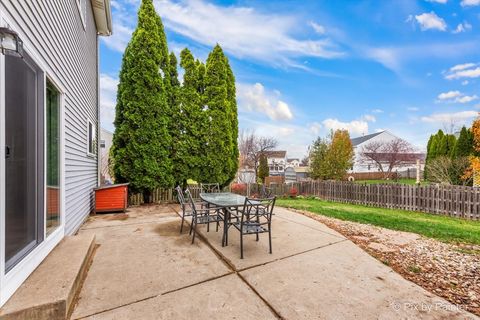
277,199 -> 480,245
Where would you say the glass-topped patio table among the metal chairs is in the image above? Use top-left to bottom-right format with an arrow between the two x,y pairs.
200,192 -> 249,247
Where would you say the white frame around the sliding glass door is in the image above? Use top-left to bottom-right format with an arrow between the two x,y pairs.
0,12 -> 66,307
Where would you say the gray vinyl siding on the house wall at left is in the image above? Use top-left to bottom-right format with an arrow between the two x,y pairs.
0,0 -> 98,234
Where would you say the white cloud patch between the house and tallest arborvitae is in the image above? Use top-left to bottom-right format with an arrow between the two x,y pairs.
100,73 -> 118,131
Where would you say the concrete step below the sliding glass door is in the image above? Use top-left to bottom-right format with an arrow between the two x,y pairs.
0,234 -> 95,320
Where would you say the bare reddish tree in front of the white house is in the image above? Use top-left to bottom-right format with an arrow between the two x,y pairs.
360,138 -> 423,178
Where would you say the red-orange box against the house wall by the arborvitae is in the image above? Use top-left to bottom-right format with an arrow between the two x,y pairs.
94,183 -> 128,213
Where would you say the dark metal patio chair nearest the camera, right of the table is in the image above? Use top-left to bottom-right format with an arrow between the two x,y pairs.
227,197 -> 276,259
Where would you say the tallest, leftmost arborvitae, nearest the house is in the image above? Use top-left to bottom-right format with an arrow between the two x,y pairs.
113,0 -> 173,201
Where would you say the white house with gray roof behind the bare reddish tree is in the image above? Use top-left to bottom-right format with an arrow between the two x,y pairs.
350,131 -> 424,173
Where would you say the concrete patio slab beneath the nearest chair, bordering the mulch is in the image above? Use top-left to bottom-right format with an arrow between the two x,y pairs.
198,208 -> 346,270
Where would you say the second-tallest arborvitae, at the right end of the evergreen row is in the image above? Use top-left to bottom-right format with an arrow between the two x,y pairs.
201,45 -> 238,185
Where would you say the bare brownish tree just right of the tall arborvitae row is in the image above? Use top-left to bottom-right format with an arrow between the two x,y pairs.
238,131 -> 278,180
